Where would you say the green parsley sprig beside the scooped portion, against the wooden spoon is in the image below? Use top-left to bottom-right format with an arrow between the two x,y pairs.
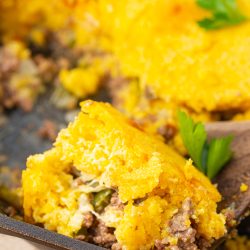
178,111 -> 233,179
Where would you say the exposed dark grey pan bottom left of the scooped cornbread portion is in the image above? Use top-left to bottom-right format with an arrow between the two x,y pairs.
0,89 -> 110,169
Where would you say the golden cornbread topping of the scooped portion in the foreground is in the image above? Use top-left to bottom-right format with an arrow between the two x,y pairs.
22,101 -> 226,249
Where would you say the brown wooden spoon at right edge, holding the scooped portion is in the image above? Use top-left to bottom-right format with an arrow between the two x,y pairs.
206,121 -> 250,221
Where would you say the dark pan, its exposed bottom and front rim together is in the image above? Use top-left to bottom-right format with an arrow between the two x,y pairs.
0,87 -> 108,250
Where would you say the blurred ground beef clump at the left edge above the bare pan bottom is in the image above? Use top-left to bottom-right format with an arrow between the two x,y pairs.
0,46 -> 42,111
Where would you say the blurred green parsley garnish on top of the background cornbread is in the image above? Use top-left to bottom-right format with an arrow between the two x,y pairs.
196,0 -> 247,30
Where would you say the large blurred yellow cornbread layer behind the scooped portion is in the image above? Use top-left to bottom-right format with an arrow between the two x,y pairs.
0,0 -> 250,137
